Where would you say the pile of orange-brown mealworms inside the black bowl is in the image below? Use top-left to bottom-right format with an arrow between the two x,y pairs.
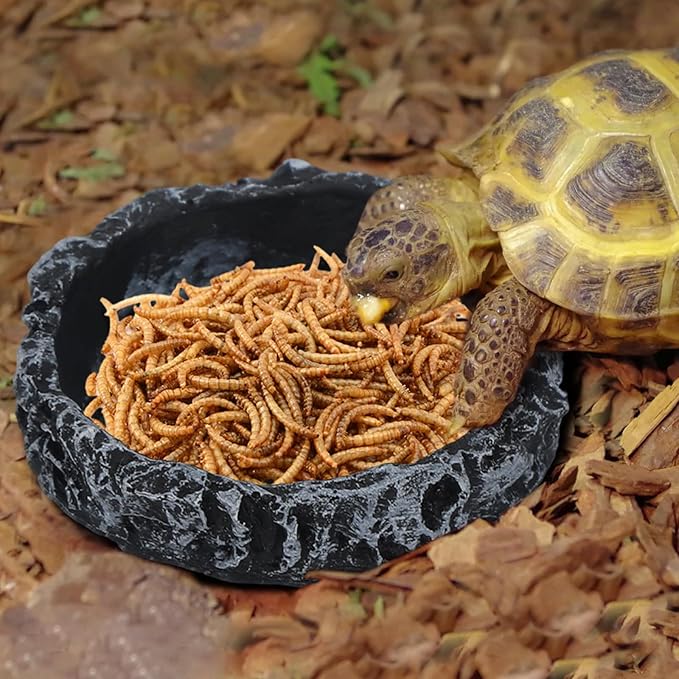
85,248 -> 468,483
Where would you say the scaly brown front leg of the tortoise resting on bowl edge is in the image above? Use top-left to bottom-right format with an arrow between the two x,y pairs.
450,277 -> 555,434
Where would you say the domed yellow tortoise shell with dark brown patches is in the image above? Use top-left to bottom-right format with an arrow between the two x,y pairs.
443,49 -> 679,339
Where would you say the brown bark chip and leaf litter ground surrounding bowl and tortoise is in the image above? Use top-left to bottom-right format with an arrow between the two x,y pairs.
0,0 -> 679,679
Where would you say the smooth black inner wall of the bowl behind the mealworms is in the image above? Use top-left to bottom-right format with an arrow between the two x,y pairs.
56,184 -> 376,406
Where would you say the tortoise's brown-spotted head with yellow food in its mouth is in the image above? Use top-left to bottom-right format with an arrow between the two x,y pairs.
343,206 -> 457,323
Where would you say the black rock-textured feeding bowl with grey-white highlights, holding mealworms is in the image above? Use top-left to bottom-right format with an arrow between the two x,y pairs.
16,160 -> 567,585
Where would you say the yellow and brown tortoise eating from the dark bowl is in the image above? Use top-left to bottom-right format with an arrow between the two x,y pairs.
344,49 -> 679,434
